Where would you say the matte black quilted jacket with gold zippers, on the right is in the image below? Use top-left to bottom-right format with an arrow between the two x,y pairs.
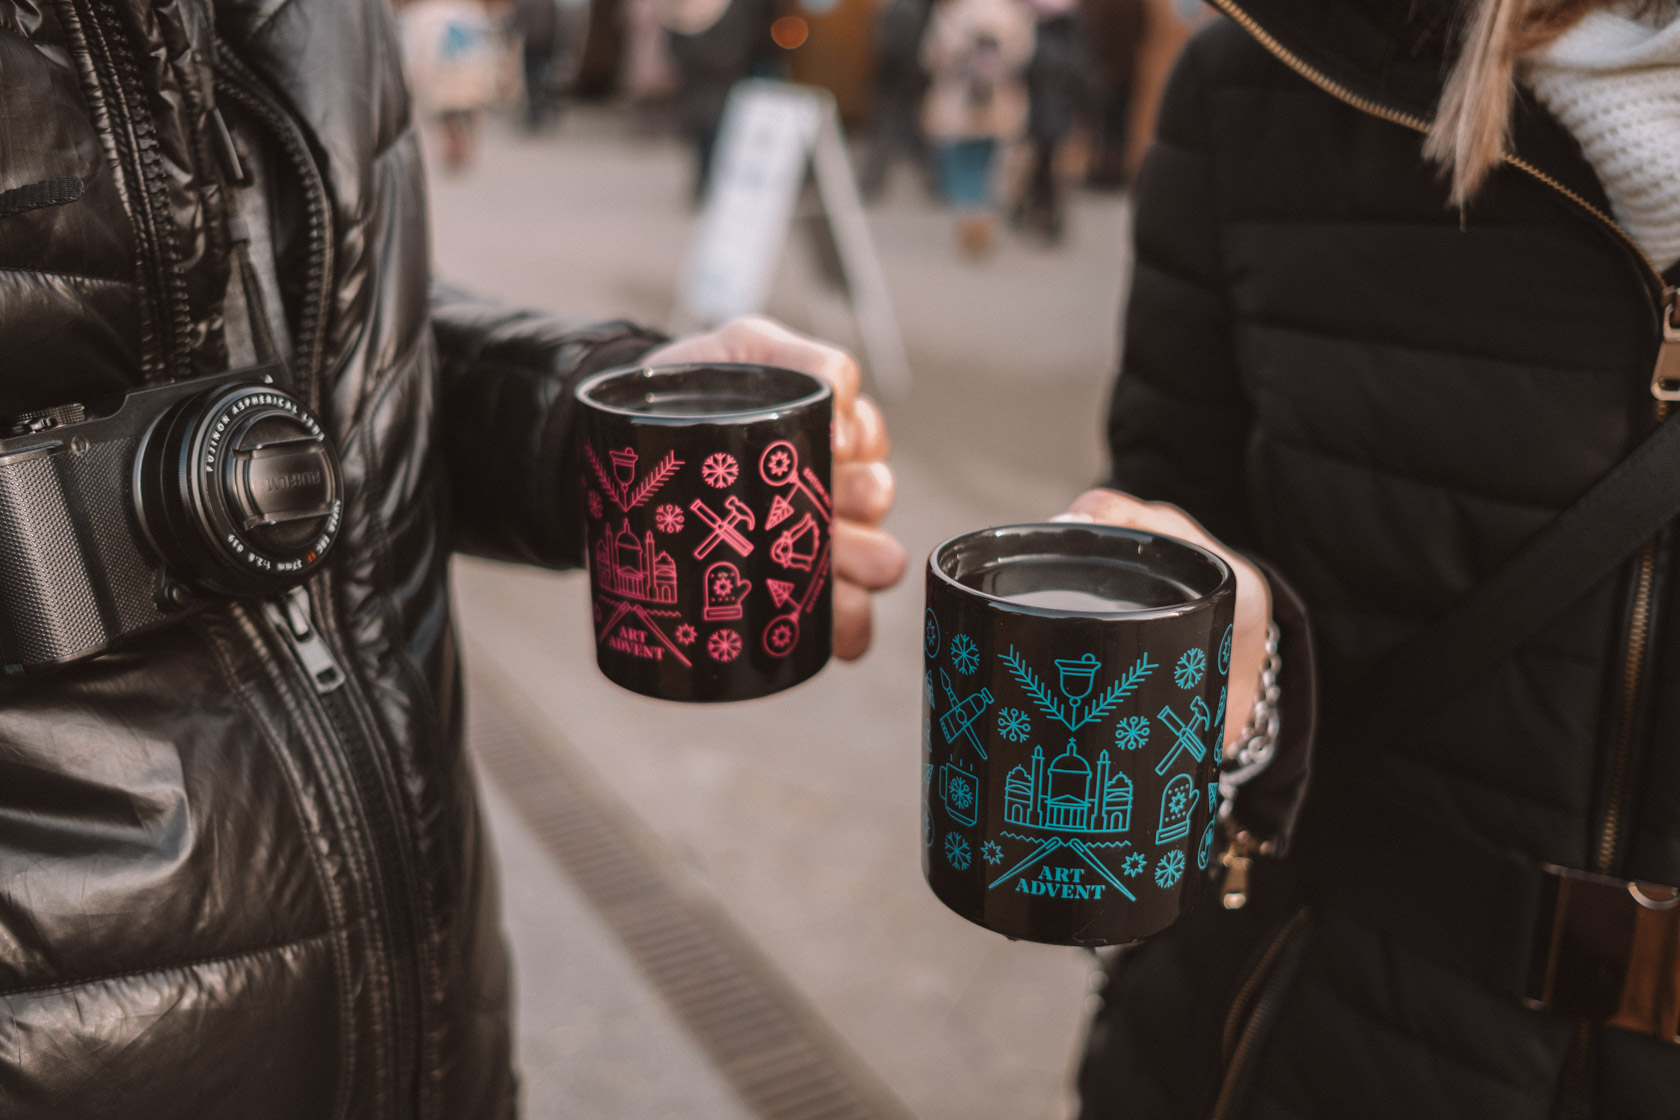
1080,0 -> 1680,1120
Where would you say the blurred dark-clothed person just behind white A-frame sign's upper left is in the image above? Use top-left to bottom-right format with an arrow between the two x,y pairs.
664,0 -> 776,203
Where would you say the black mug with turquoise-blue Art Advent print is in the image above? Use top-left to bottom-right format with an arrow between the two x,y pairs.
922,524 -> 1236,945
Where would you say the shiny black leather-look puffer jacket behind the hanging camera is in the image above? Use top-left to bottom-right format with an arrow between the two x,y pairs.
0,0 -> 654,1120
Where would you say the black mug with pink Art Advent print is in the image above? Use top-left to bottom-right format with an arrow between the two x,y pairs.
576,363 -> 833,702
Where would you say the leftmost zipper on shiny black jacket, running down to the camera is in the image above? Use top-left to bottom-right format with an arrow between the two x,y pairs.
66,0 -> 193,383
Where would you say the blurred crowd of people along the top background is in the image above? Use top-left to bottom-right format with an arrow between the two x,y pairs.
395,0 -> 1201,259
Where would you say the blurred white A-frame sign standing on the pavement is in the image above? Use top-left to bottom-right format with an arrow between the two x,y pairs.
677,79 -> 911,391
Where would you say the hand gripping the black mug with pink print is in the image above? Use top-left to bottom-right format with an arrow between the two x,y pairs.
642,316 -> 909,660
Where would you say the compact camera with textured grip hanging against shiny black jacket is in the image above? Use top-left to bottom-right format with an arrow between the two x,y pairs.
0,364 -> 343,675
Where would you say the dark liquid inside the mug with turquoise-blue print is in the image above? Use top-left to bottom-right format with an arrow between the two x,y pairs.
959,556 -> 1196,615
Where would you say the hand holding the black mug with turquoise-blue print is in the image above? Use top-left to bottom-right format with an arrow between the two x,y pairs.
1057,490 -> 1272,742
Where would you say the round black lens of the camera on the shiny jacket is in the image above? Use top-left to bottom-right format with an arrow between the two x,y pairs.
134,383 -> 343,596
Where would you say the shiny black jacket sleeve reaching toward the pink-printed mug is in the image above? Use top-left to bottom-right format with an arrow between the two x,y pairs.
432,285 -> 662,568
